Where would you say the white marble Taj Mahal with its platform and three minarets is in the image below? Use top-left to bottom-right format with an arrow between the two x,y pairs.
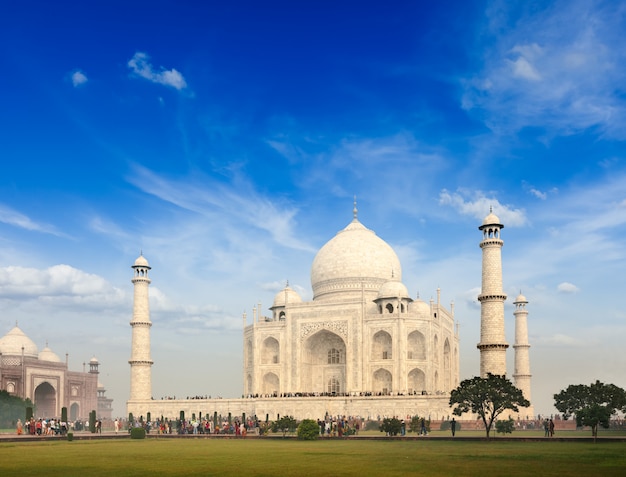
127,203 -> 534,419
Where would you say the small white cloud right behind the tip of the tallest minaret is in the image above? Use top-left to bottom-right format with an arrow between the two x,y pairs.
439,189 -> 528,227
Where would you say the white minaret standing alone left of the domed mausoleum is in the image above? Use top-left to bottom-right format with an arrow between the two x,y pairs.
128,254 -> 152,401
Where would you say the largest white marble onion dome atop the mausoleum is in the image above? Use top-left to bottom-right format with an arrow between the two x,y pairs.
311,217 -> 402,300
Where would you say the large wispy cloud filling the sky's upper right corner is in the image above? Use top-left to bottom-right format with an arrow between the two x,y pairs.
463,0 -> 626,139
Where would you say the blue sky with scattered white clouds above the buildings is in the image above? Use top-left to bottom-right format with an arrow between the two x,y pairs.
0,0 -> 626,415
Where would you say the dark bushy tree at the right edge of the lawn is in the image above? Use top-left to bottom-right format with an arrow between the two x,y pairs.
554,380 -> 626,439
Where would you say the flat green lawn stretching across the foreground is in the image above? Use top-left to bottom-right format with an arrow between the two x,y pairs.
0,438 -> 626,477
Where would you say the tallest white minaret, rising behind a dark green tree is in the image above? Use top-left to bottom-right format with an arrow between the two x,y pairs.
477,209 -> 509,378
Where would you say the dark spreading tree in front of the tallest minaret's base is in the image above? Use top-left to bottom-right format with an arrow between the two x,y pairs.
450,373 -> 530,439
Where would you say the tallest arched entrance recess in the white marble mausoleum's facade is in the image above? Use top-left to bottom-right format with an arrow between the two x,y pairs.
300,330 -> 346,394
